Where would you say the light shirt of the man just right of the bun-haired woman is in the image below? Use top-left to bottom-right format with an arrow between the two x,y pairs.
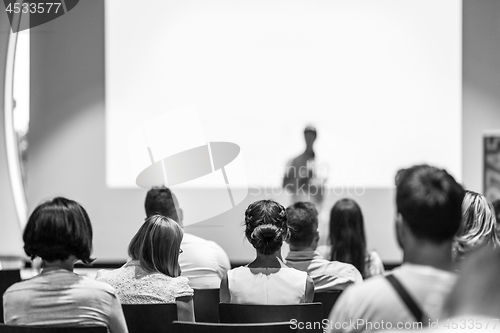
285,251 -> 363,292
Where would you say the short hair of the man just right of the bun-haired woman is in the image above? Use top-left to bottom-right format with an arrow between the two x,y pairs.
286,202 -> 318,246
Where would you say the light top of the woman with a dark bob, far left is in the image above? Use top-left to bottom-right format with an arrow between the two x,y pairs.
3,269 -> 127,333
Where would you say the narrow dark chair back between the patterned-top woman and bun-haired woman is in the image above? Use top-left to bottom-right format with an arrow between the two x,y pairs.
193,289 -> 220,323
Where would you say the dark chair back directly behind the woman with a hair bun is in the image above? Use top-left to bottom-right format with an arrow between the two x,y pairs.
219,303 -> 323,332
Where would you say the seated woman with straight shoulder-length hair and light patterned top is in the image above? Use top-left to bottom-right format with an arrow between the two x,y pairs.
96,215 -> 194,321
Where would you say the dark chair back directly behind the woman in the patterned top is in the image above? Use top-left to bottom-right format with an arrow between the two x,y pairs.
122,303 -> 177,333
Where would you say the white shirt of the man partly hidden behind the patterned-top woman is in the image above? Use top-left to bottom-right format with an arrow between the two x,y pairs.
179,233 -> 231,289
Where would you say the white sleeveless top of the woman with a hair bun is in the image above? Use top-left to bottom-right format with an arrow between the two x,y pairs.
227,266 -> 307,305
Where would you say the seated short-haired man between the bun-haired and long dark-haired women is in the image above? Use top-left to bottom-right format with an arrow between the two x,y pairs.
285,202 -> 363,292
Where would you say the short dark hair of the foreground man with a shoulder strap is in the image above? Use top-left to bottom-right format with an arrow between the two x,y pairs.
396,165 -> 465,243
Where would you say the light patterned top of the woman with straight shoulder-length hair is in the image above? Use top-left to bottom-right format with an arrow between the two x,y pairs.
96,260 -> 194,304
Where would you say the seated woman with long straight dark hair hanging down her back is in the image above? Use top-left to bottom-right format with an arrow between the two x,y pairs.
317,199 -> 384,279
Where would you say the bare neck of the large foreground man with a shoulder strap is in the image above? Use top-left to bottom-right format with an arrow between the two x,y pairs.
403,241 -> 455,272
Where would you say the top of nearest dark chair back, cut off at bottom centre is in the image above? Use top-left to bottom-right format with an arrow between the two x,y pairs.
172,321 -> 296,333
